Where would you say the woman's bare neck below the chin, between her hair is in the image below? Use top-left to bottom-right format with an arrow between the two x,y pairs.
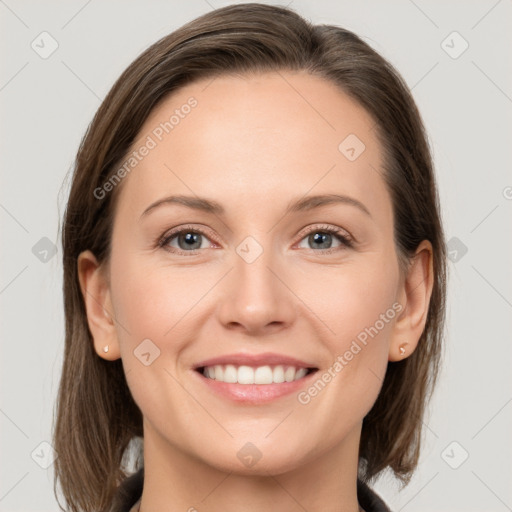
136,423 -> 361,512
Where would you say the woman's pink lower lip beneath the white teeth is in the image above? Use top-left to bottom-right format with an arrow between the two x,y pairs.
194,370 -> 318,404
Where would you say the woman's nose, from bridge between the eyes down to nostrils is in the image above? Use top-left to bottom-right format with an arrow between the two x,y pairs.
216,233 -> 294,331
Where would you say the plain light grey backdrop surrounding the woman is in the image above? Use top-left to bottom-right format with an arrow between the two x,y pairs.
0,0 -> 512,512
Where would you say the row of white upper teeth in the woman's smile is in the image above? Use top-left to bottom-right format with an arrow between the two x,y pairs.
203,364 -> 308,384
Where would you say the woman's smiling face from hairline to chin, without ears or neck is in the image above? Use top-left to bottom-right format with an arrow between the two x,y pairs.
95,72 -> 403,474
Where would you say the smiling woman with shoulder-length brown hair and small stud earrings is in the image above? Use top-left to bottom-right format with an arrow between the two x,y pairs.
54,4 -> 446,512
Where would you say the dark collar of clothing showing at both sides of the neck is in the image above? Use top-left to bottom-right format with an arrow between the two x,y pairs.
116,468 -> 391,512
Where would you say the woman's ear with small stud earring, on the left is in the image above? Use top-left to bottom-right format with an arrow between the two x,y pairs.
77,251 -> 121,361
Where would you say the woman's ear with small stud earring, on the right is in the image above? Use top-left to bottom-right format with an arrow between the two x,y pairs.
388,240 -> 434,361
